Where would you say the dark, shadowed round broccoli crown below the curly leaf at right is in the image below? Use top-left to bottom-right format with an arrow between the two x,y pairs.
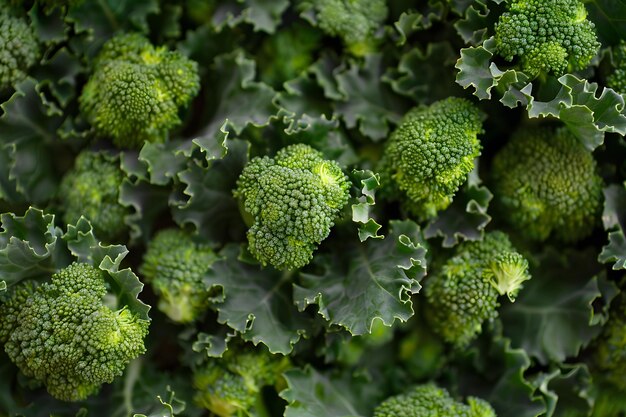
491,128 -> 602,242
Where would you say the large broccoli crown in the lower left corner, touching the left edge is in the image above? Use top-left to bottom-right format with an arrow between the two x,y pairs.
0,263 -> 148,401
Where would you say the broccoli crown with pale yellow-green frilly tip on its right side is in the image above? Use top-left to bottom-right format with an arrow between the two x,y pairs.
424,231 -> 530,347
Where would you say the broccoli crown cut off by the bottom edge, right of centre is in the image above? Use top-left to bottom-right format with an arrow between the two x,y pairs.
374,383 -> 496,417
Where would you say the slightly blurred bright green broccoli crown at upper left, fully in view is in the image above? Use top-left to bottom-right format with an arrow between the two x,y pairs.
80,34 -> 200,148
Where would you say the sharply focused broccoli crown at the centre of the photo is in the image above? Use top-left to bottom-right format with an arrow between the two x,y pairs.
235,144 -> 350,269
